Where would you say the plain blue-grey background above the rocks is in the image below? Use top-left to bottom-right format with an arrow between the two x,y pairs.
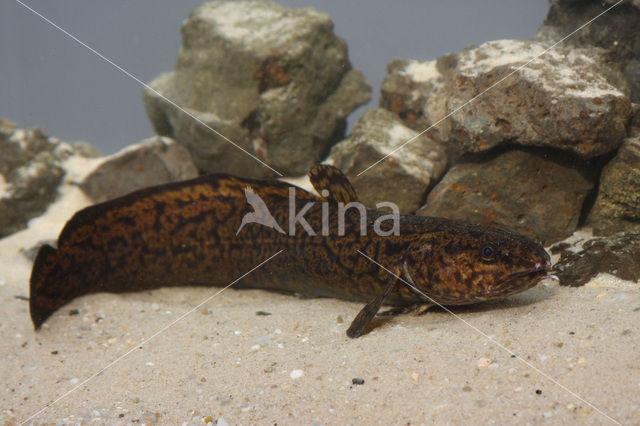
0,0 -> 548,154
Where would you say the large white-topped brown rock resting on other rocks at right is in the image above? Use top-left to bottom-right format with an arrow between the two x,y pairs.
381,40 -> 632,158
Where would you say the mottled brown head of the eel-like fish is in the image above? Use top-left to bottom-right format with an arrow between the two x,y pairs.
404,222 -> 551,305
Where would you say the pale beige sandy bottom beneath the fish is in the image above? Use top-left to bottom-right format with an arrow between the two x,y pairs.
0,166 -> 640,425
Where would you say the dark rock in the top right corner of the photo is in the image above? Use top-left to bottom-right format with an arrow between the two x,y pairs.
533,0 -> 640,103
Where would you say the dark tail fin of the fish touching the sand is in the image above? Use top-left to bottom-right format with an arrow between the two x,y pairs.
29,244 -> 72,330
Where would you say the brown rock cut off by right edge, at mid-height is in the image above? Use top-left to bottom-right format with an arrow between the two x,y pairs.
587,132 -> 640,235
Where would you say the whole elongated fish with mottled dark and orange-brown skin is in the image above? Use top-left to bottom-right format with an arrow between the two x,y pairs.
30,166 -> 549,337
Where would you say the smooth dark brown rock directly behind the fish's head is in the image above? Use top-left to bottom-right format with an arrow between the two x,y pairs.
418,149 -> 594,243
